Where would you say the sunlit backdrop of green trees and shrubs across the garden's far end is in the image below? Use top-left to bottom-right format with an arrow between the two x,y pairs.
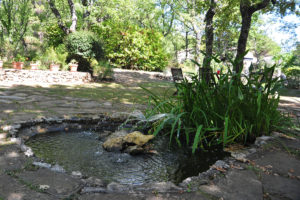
0,0 -> 299,71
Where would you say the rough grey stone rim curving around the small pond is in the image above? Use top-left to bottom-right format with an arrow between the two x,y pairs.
2,115 -> 278,194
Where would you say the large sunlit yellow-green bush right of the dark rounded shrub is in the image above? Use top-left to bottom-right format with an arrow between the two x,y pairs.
94,22 -> 168,71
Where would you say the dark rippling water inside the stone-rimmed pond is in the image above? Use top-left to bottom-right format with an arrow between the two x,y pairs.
26,131 -> 225,185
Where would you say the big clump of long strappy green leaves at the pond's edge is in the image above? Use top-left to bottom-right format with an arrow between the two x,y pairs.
147,61 -> 286,152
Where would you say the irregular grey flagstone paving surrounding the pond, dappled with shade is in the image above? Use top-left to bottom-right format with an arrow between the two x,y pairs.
0,72 -> 300,200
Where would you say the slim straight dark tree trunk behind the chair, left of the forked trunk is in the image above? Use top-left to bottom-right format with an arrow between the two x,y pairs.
199,0 -> 216,83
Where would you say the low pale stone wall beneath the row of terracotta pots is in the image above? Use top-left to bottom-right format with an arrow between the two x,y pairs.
0,69 -> 92,84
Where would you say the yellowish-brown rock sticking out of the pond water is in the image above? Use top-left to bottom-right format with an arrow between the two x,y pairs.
102,131 -> 154,154
